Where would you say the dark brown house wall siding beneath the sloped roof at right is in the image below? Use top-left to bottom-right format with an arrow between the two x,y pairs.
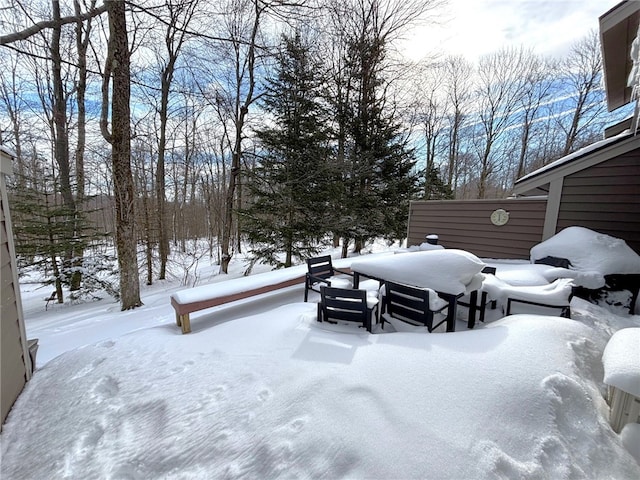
556,155 -> 640,253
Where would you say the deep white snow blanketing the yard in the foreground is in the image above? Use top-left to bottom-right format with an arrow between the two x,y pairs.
0,232 -> 640,479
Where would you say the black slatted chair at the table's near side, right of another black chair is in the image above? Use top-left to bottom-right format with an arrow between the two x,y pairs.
380,282 -> 447,332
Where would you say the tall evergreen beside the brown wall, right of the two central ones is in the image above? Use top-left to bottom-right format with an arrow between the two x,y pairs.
336,32 -> 419,251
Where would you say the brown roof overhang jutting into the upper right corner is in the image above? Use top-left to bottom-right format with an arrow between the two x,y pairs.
600,0 -> 640,112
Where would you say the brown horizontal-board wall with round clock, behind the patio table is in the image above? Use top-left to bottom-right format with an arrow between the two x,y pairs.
407,199 -> 546,259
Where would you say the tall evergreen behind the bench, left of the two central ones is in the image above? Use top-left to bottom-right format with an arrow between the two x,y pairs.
242,33 -> 329,267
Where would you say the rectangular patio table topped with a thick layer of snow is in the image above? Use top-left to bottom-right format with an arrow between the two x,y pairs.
351,249 -> 485,332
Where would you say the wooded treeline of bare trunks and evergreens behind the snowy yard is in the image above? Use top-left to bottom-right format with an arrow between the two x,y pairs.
0,0 -> 624,308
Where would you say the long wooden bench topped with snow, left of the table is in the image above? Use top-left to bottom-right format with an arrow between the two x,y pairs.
171,266 -> 307,333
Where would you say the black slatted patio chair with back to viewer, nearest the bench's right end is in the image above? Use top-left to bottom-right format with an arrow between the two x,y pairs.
318,286 -> 377,332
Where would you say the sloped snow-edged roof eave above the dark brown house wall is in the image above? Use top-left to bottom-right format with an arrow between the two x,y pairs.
513,130 -> 640,196
